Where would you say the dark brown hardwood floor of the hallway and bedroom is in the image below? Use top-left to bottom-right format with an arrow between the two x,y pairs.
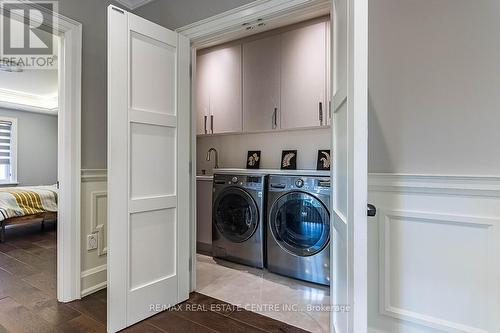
0,222 -> 306,333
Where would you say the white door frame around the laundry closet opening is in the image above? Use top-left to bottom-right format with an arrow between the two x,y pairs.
176,0 -> 331,292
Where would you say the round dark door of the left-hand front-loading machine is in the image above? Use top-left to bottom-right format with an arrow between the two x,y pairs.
214,187 -> 259,243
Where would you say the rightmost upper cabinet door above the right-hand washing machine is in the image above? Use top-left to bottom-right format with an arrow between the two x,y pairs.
281,22 -> 327,129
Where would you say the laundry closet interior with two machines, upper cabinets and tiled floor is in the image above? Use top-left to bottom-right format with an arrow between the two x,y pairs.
192,8 -> 333,332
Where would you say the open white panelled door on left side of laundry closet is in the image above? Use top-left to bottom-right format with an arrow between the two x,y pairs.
108,6 -> 190,332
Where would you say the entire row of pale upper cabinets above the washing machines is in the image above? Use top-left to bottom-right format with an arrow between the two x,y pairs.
196,19 -> 330,134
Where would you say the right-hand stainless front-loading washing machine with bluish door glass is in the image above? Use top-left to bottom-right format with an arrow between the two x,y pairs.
267,175 -> 330,285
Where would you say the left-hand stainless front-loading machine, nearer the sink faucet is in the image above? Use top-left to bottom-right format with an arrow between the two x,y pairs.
212,173 -> 266,268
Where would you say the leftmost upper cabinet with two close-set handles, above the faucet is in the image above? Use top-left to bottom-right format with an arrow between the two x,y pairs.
196,45 -> 242,134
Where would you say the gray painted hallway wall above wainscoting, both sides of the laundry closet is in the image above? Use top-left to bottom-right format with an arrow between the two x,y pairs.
60,0 -> 500,174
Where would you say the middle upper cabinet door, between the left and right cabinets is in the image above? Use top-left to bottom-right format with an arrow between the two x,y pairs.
243,35 -> 281,132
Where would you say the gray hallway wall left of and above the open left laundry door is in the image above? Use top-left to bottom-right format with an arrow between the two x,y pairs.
59,0 -> 251,169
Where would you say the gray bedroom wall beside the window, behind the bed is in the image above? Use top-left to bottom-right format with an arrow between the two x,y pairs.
0,109 -> 57,186
